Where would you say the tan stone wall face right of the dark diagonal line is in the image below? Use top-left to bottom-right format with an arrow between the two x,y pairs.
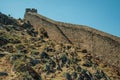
60,26 -> 120,66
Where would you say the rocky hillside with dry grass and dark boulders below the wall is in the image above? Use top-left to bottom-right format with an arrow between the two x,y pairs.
0,11 -> 120,80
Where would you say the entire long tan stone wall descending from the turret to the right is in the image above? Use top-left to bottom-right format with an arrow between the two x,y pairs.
25,12 -> 120,67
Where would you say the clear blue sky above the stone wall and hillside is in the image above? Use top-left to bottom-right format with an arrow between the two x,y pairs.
0,0 -> 120,37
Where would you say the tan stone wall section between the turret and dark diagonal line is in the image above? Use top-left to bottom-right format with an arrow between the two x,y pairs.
25,13 -> 69,43
